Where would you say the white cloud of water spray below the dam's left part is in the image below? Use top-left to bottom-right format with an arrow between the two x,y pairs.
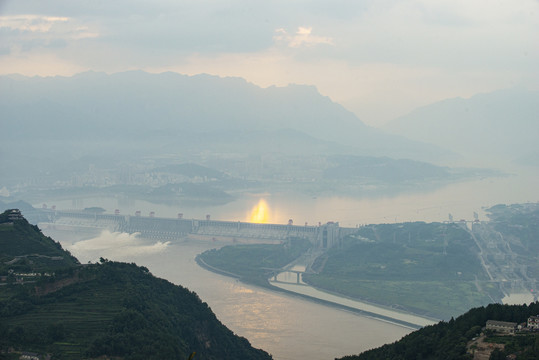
68,230 -> 170,262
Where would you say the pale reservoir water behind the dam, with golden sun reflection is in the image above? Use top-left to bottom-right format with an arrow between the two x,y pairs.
34,169 -> 539,227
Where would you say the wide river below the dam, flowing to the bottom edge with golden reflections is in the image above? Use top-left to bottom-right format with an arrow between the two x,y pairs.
44,228 -> 411,360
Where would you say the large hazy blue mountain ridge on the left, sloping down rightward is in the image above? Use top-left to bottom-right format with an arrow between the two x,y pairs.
0,71 -> 454,161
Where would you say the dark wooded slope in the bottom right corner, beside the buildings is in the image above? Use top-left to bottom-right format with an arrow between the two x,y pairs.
342,302 -> 539,360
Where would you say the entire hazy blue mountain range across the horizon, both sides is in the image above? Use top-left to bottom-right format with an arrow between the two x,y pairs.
0,71 -> 539,197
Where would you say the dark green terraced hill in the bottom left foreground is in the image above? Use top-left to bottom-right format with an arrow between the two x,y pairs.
0,211 -> 271,360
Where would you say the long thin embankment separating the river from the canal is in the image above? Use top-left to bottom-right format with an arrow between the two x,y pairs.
195,255 -> 430,330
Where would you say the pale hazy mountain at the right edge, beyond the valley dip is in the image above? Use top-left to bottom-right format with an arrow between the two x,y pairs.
383,88 -> 539,164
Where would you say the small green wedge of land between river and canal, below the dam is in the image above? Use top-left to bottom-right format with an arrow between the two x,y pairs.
198,238 -> 311,285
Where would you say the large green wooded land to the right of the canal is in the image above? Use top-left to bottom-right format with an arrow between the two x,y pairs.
303,222 -> 497,319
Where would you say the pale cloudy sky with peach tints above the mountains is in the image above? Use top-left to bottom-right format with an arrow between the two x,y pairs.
0,0 -> 539,125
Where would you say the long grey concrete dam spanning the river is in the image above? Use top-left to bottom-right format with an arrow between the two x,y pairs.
33,209 -> 355,249
